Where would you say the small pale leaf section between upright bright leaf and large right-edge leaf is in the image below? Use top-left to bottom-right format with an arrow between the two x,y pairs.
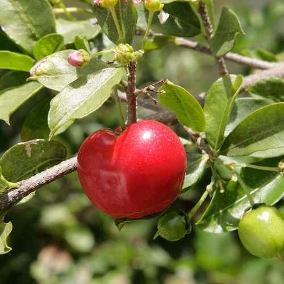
225,97 -> 271,136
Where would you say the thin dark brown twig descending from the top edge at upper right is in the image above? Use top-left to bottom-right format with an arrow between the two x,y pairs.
198,1 -> 229,77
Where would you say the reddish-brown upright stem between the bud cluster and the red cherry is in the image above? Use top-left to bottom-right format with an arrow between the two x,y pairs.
126,61 -> 137,125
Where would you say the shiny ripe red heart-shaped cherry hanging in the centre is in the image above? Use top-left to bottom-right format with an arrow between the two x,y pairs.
78,120 -> 186,218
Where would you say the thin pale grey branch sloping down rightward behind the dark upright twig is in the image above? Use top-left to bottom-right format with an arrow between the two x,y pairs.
174,37 -> 279,70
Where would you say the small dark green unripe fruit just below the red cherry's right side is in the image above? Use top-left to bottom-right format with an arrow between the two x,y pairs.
156,212 -> 187,241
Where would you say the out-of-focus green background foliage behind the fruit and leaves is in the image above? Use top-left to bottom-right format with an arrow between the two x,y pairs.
0,0 -> 284,284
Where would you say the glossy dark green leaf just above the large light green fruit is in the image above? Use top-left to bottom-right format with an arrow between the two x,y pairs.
197,157 -> 284,233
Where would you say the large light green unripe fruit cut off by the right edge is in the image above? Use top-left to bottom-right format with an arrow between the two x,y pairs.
238,206 -> 284,258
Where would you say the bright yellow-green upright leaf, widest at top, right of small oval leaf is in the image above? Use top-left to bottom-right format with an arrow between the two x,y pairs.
204,75 -> 243,150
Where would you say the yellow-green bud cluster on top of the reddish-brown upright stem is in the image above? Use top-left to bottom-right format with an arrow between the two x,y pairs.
114,44 -> 143,65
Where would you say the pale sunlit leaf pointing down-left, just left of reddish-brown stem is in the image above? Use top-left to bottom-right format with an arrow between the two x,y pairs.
48,61 -> 125,136
